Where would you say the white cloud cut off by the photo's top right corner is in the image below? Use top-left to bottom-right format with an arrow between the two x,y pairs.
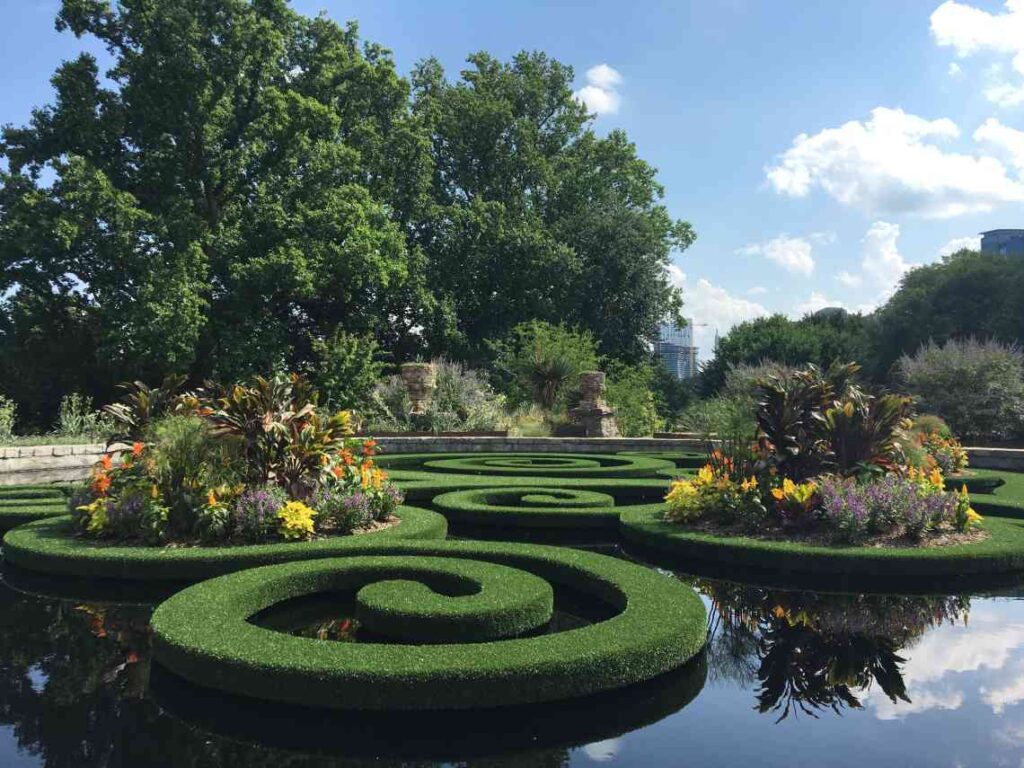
931,0 -> 1024,106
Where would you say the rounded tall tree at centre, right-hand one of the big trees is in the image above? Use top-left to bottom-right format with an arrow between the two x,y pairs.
413,53 -> 694,359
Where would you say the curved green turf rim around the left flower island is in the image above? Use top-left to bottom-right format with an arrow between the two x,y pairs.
3,507 -> 447,582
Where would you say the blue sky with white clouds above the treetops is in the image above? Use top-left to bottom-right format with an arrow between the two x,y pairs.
6,0 -> 1024,355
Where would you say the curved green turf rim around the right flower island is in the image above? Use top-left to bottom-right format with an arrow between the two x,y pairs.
620,508 -> 1024,579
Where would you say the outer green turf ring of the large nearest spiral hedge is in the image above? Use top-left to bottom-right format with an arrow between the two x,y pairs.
152,541 -> 707,712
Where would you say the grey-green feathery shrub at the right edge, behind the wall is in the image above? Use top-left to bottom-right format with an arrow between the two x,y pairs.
897,338 -> 1024,439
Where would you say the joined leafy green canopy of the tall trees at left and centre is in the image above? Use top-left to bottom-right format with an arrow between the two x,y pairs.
0,0 -> 694,428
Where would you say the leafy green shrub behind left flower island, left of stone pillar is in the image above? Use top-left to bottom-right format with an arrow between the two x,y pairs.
310,330 -> 384,413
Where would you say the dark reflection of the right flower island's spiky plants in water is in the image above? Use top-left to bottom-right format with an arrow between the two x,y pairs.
695,581 -> 971,722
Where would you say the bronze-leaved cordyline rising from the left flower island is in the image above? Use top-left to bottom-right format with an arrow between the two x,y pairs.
200,374 -> 352,499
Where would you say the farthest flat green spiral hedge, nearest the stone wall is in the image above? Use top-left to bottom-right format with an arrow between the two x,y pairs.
378,454 -> 674,480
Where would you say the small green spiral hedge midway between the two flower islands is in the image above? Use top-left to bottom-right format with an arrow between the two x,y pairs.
433,481 -> 667,529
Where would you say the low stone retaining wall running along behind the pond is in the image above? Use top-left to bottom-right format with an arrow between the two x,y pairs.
0,436 -> 1024,485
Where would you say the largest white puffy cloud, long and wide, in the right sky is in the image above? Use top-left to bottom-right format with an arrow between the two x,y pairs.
765,107 -> 1024,218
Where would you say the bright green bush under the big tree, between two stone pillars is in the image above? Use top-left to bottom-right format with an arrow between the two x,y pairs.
490,321 -> 600,411
